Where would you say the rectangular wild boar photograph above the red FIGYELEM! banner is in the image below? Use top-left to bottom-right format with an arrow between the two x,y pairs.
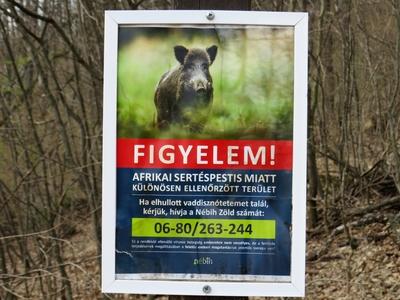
117,25 -> 294,139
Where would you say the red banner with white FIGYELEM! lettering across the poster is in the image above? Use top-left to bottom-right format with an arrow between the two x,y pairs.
117,139 -> 293,170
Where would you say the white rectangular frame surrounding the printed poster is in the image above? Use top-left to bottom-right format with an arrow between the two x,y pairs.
102,10 -> 308,297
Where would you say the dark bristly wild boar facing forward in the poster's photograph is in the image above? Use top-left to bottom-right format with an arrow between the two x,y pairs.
154,45 -> 218,132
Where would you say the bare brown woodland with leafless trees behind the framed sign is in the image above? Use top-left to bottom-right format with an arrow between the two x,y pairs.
0,0 -> 400,299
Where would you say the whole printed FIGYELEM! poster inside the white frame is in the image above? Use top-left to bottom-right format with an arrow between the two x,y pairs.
115,25 -> 294,282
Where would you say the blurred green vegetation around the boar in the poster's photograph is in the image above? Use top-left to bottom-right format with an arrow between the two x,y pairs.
118,26 -> 294,139
